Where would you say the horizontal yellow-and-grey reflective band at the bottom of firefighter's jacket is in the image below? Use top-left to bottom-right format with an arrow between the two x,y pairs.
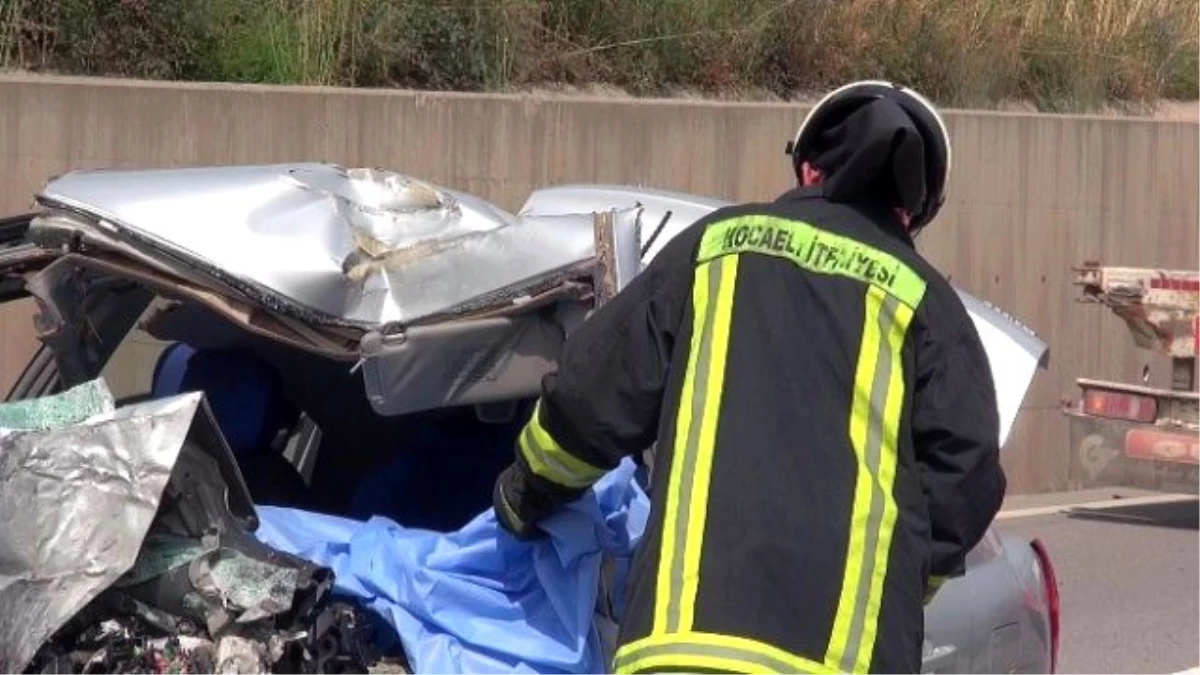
613,632 -> 840,675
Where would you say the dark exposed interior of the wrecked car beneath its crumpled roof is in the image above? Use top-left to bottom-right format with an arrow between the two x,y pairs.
10,252 -> 544,532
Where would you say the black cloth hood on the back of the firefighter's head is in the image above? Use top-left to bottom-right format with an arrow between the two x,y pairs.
804,98 -> 926,222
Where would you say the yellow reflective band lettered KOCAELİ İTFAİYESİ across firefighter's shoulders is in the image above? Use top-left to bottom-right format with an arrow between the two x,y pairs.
696,215 -> 925,309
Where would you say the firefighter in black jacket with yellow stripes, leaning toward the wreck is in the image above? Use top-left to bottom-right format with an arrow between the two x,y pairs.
493,80 -> 1006,675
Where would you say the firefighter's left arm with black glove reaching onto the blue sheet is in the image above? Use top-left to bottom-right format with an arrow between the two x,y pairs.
493,241 -> 690,536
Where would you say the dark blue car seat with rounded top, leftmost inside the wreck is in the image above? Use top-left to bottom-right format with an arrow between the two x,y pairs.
151,342 -> 307,507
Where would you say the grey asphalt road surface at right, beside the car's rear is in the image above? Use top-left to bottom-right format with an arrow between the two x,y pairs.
997,491 -> 1200,675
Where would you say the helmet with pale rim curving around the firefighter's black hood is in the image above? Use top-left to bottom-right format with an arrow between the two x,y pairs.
787,79 -> 952,235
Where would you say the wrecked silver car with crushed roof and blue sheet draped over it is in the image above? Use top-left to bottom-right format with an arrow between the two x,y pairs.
0,163 -> 1058,674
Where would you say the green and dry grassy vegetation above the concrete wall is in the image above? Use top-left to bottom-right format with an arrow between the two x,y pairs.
0,0 -> 1200,110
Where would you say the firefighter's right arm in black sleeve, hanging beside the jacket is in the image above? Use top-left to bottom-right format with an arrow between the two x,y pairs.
912,316 -> 1007,586
